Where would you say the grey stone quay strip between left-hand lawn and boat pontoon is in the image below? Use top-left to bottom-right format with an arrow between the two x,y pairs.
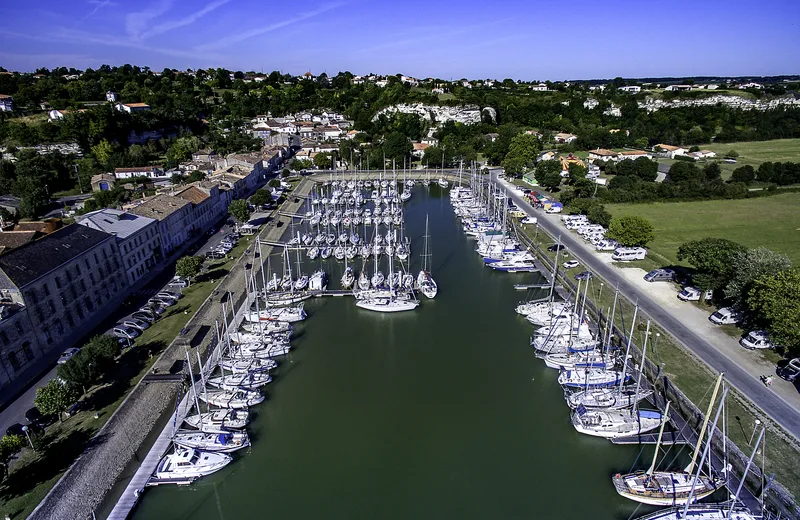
28,179 -> 313,520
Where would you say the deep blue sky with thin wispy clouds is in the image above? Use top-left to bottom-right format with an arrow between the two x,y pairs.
0,0 -> 800,80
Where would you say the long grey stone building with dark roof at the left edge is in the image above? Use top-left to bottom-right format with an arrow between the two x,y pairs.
0,224 -> 128,393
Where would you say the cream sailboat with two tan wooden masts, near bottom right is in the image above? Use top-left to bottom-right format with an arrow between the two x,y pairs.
611,374 -> 724,506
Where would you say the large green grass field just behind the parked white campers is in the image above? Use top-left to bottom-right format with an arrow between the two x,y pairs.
606,193 -> 800,265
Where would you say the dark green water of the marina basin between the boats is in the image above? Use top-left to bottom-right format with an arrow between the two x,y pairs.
133,187 -> 649,520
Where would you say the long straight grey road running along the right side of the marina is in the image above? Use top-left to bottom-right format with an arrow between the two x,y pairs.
492,172 -> 800,440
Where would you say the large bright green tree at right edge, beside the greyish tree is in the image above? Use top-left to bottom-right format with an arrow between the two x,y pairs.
747,267 -> 800,356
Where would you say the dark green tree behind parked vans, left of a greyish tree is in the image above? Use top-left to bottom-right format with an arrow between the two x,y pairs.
678,237 -> 747,291
